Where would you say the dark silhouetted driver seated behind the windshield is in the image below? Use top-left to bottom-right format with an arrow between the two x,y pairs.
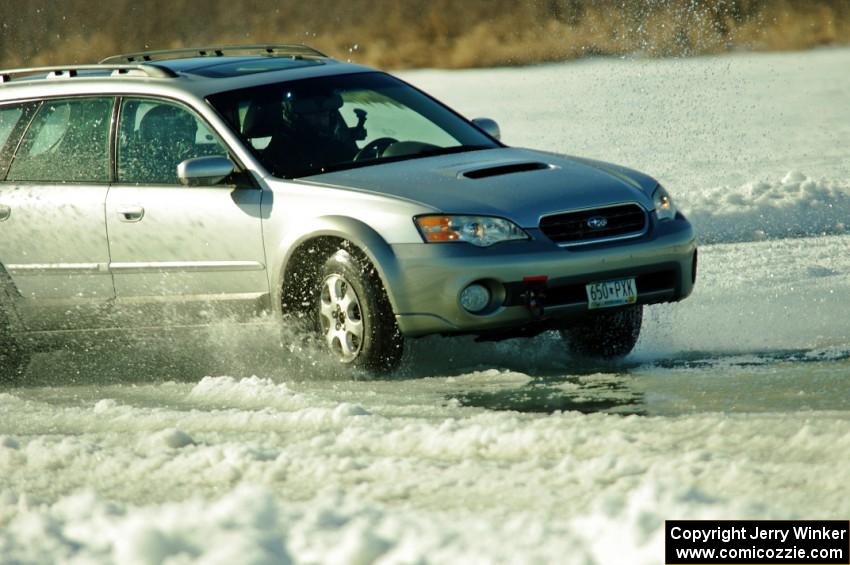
266,92 -> 365,176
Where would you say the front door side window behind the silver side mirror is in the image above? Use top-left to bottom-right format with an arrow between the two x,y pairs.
118,98 -> 227,184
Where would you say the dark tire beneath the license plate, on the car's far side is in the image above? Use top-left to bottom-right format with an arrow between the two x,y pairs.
560,306 -> 643,359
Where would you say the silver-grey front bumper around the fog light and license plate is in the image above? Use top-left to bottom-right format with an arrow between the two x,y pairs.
385,215 -> 696,337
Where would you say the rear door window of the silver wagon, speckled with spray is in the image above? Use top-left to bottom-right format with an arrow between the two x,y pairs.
6,98 -> 113,182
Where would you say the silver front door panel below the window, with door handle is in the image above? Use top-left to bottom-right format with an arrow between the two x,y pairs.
106,184 -> 269,321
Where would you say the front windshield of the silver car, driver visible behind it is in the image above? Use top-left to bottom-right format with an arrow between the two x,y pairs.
209,73 -> 499,178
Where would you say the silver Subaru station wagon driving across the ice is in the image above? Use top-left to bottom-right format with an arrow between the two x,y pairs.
0,45 -> 697,379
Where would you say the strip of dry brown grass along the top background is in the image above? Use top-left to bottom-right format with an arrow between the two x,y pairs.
0,0 -> 850,68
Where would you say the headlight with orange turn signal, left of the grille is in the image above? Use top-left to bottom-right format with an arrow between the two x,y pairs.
413,216 -> 530,247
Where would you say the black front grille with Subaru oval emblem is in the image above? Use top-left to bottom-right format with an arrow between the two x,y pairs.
540,204 -> 647,245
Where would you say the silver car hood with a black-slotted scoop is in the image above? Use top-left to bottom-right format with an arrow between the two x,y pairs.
301,148 -> 657,228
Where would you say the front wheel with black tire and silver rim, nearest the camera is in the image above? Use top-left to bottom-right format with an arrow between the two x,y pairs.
315,249 -> 404,373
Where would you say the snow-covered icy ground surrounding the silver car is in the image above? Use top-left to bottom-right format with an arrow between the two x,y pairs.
0,49 -> 850,564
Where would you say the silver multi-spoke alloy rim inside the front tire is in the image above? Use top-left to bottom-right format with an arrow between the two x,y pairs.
319,275 -> 363,363
